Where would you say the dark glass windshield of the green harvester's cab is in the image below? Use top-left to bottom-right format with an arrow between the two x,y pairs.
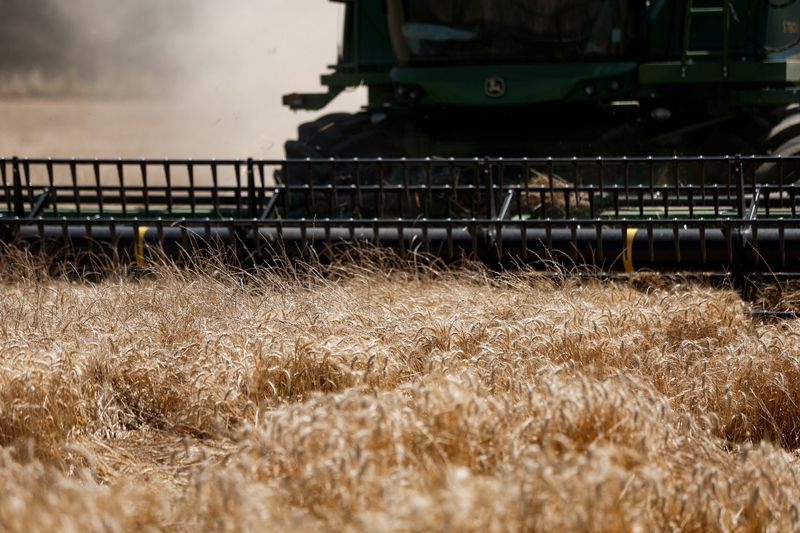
394,0 -> 633,63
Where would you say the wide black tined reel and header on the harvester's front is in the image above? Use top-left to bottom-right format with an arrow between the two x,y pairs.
0,157 -> 800,284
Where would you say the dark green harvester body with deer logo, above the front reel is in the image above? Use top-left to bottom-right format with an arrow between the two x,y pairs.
284,0 -> 800,161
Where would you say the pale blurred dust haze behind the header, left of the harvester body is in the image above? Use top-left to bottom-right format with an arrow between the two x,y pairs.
0,0 -> 364,158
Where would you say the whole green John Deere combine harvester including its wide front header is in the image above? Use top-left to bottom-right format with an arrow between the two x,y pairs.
0,0 -> 800,308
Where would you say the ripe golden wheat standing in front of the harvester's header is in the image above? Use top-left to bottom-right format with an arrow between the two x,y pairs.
0,253 -> 800,531
